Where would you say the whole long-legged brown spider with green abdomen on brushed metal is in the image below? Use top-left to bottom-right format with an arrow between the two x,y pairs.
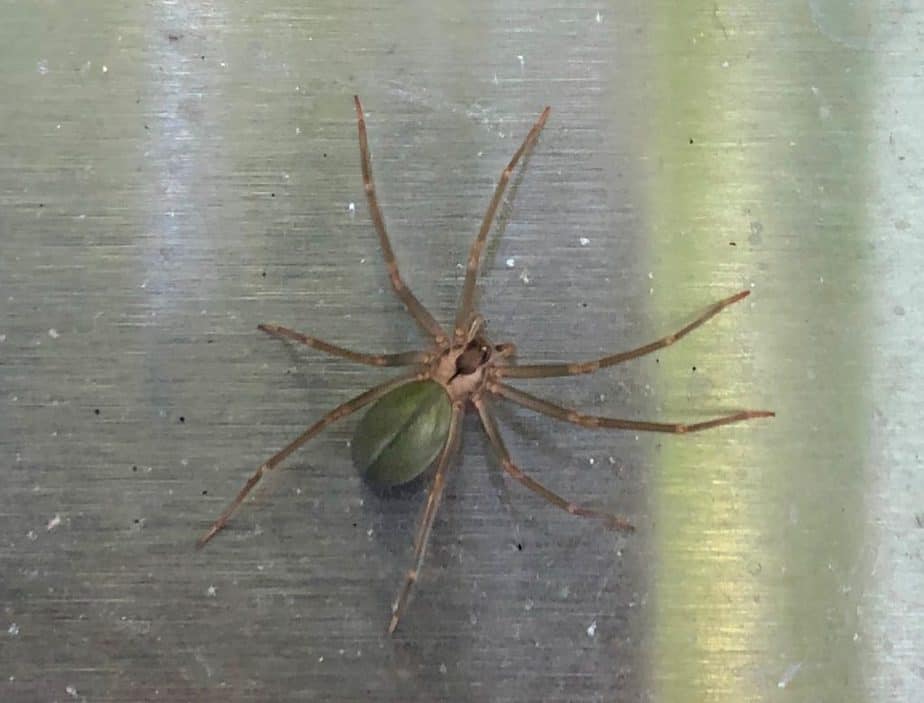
197,96 -> 774,633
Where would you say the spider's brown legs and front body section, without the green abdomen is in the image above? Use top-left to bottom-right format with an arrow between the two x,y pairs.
197,96 -> 774,633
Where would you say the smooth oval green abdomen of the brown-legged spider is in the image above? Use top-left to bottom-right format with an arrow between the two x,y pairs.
352,380 -> 452,486
